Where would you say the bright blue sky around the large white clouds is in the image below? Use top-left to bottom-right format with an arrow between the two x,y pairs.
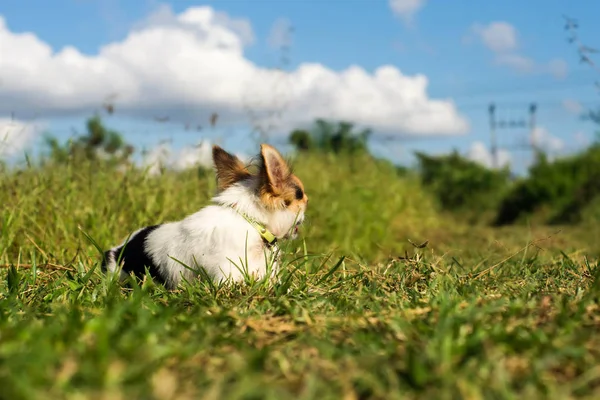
0,0 -> 600,169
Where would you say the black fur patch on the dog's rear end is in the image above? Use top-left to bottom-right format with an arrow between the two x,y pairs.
102,225 -> 165,284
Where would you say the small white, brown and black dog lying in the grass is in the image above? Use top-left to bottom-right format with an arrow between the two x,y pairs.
102,144 -> 308,289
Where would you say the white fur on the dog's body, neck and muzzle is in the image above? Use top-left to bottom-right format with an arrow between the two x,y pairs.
107,179 -> 304,288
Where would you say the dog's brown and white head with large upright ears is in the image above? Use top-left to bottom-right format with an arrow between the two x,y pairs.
213,144 -> 308,238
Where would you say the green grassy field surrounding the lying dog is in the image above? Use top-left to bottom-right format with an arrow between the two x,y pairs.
0,152 -> 600,400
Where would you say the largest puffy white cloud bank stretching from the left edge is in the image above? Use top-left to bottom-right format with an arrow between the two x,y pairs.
0,7 -> 468,135
